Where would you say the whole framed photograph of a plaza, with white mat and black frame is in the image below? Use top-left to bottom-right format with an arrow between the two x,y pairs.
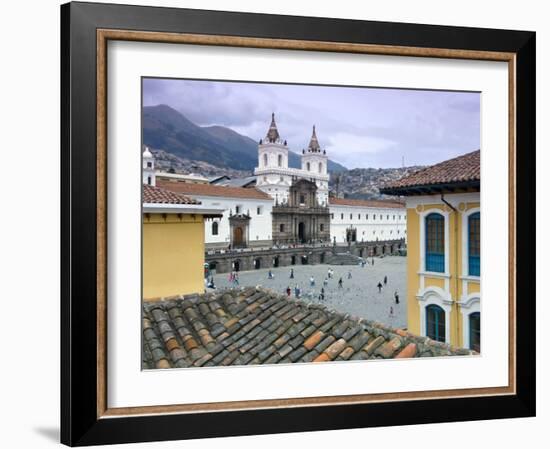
61,3 -> 536,446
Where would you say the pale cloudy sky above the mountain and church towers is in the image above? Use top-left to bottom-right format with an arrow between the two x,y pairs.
143,79 -> 480,168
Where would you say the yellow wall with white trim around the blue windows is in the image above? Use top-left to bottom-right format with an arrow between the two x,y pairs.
407,198 -> 480,346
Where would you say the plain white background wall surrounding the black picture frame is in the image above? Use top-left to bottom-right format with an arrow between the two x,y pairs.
4,0 -> 550,449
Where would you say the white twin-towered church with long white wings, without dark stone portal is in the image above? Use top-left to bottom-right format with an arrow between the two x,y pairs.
142,114 -> 407,250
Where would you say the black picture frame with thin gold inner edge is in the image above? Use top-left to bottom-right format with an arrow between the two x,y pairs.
61,2 -> 536,446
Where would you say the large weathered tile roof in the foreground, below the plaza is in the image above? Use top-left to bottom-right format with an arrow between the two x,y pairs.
142,287 -> 475,369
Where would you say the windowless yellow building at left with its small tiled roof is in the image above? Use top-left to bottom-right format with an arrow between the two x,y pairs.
142,182 -> 222,301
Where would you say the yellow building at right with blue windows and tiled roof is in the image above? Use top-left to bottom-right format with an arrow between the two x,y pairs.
381,151 -> 481,352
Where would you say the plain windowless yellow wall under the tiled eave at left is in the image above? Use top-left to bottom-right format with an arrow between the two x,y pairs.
143,214 -> 204,300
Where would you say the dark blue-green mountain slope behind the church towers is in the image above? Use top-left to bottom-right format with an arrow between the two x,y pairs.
143,105 -> 346,172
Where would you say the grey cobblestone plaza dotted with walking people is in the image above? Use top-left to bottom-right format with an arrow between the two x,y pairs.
214,256 -> 407,327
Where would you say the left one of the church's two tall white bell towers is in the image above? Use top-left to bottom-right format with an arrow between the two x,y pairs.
255,113 -> 292,204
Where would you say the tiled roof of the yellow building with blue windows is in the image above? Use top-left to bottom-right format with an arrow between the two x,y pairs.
380,150 -> 480,193
